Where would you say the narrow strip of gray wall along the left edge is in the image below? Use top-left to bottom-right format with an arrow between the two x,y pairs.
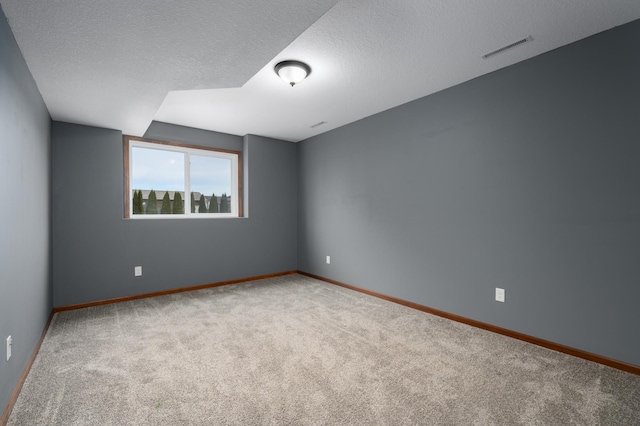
0,5 -> 51,415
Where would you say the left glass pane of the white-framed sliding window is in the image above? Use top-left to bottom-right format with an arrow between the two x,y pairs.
131,147 -> 185,214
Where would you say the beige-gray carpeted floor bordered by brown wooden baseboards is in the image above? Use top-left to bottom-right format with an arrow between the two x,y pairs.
8,275 -> 640,426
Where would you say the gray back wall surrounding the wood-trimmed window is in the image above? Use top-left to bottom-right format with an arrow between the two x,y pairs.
52,122 -> 297,306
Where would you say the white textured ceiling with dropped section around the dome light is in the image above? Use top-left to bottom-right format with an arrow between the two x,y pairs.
0,0 -> 640,141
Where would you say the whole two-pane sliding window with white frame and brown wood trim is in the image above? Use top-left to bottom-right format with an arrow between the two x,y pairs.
124,136 -> 242,219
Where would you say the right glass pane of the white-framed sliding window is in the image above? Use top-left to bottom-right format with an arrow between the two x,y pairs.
189,154 -> 232,213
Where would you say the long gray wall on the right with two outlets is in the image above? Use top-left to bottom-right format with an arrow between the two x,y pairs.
299,21 -> 640,365
